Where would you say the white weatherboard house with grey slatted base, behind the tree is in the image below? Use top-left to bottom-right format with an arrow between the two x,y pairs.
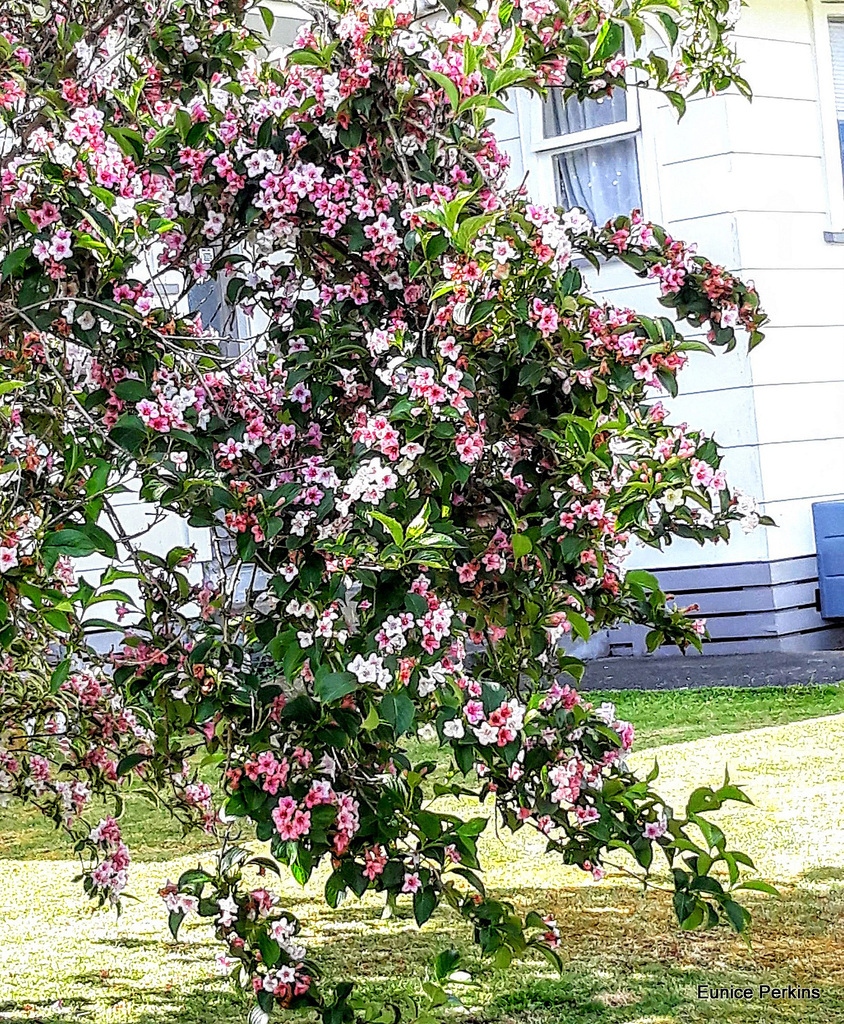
162,0 -> 844,655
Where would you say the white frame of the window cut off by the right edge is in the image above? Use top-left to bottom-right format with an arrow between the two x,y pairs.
810,0 -> 844,233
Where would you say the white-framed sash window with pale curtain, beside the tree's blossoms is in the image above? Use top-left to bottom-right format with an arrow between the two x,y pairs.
533,89 -> 642,224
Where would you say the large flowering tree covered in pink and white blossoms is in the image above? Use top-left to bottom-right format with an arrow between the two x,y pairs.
0,0 -> 778,1022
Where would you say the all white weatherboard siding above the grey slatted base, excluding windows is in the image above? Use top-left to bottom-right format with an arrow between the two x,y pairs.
514,0 -> 844,585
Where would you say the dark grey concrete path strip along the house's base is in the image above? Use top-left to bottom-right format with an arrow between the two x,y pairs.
581,650 -> 844,690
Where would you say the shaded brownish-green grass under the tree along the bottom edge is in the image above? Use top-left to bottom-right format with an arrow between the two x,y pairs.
0,880 -> 844,1024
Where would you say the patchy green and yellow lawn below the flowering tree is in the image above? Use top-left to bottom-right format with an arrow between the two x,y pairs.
0,687 -> 844,1024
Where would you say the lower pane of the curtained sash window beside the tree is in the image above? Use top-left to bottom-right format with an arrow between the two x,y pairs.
554,137 -> 642,224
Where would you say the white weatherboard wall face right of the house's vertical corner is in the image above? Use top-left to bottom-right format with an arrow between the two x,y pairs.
734,0 -> 844,559
